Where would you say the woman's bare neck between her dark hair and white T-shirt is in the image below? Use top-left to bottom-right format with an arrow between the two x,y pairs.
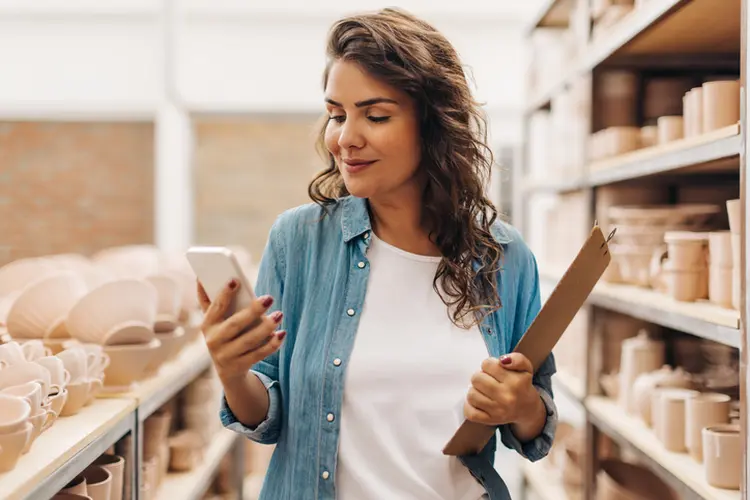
368,188 -> 441,256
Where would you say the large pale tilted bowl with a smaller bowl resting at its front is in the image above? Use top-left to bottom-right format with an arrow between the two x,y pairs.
66,279 -> 157,345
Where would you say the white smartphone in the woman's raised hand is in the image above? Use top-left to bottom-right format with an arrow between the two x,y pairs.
186,246 -> 255,318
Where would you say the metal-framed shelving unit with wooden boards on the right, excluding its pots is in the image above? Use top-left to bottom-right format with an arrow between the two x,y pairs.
512,0 -> 750,500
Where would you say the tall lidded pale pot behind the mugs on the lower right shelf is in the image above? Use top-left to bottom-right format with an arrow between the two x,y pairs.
618,330 -> 664,414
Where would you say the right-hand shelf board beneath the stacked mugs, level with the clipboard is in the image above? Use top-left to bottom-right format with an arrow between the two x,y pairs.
589,282 -> 741,348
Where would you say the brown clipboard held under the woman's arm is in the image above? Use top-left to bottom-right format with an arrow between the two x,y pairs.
443,223 -> 616,456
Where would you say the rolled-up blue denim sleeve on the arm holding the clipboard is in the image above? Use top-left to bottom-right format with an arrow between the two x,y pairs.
499,240 -> 558,462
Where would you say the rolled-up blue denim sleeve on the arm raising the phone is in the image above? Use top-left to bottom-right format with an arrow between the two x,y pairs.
219,220 -> 286,444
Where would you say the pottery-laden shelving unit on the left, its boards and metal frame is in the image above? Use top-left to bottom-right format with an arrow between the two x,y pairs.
0,340 -> 244,500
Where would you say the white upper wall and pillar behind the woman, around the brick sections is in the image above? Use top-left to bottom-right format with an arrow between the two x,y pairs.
0,0 -> 535,248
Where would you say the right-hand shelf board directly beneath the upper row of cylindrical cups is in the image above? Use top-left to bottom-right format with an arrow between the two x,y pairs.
585,124 -> 742,186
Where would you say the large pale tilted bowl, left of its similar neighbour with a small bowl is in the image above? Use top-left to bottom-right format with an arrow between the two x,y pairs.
6,272 -> 87,338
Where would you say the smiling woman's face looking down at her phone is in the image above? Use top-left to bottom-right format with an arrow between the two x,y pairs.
325,61 -> 421,199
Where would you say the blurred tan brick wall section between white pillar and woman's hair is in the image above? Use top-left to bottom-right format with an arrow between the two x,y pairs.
195,116 -> 322,261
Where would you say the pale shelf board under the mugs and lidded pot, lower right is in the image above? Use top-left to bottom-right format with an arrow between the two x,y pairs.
586,396 -> 741,500
